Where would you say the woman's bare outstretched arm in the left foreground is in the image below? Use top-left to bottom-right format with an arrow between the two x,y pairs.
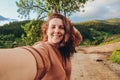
0,48 -> 37,80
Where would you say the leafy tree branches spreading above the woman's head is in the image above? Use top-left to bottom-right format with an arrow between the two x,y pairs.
16,0 -> 91,19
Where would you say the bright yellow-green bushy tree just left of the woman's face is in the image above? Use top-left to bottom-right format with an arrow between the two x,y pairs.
21,20 -> 43,45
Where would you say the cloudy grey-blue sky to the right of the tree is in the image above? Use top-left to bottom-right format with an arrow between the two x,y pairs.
71,0 -> 120,22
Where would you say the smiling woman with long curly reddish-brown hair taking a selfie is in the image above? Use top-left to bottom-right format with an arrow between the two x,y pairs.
0,13 -> 82,80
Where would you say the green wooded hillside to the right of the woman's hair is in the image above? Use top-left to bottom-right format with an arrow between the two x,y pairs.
73,18 -> 120,45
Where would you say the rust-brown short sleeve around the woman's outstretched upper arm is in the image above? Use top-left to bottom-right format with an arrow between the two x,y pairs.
21,44 -> 50,80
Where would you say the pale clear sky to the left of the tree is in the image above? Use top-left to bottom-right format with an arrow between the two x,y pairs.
0,0 -> 20,19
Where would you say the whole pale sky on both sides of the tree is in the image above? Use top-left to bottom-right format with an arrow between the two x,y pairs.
0,0 -> 120,22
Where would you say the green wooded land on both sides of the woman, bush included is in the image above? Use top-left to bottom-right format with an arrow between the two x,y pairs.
0,18 -> 120,48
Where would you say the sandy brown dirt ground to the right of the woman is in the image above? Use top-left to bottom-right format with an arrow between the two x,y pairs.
71,43 -> 120,80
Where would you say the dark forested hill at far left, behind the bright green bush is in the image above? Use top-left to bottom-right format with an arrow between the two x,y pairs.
0,20 -> 29,37
